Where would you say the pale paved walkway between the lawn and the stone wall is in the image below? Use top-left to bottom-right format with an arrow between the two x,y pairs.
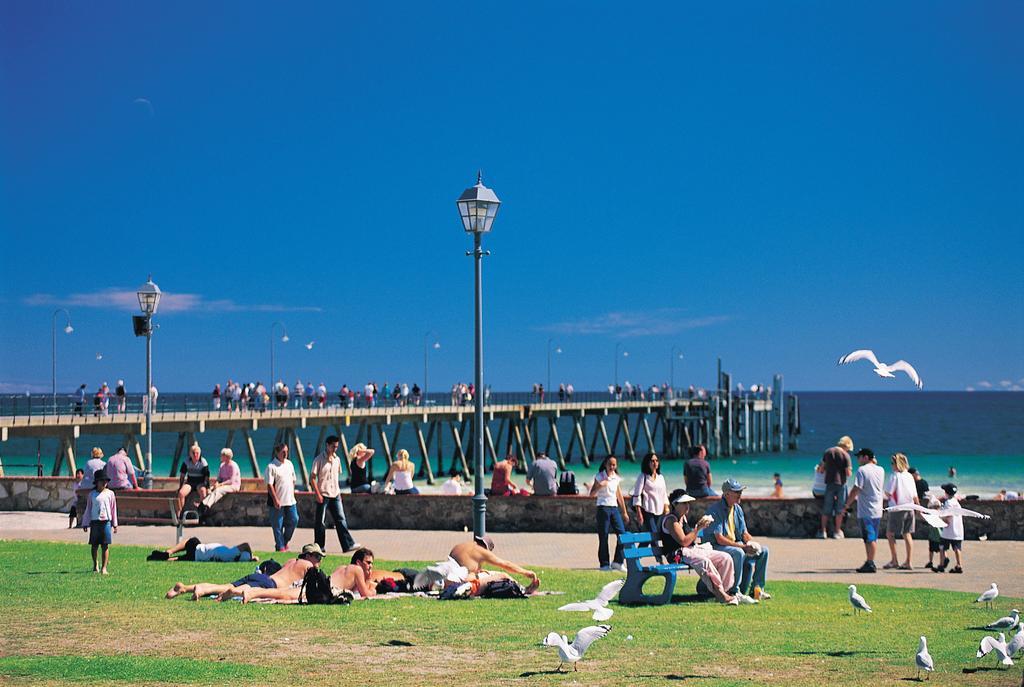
0,512 -> 1024,597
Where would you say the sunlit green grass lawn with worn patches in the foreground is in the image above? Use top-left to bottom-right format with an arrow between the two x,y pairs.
0,542 -> 1021,687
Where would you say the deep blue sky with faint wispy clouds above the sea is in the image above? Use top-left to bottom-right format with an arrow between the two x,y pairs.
0,1 -> 1024,391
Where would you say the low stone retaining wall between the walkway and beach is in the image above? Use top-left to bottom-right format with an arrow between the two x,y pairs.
0,477 -> 1024,540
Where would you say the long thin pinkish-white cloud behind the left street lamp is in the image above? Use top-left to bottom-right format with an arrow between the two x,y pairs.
23,289 -> 322,313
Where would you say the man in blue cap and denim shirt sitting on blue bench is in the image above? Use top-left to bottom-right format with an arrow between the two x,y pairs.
703,479 -> 771,603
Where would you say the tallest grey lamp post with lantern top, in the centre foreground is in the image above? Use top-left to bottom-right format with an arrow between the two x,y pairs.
456,172 -> 502,536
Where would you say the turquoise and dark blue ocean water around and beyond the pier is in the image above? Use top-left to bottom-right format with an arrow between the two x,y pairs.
0,392 -> 1024,497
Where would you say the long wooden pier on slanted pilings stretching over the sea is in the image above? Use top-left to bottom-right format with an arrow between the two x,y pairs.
0,376 -> 800,483
